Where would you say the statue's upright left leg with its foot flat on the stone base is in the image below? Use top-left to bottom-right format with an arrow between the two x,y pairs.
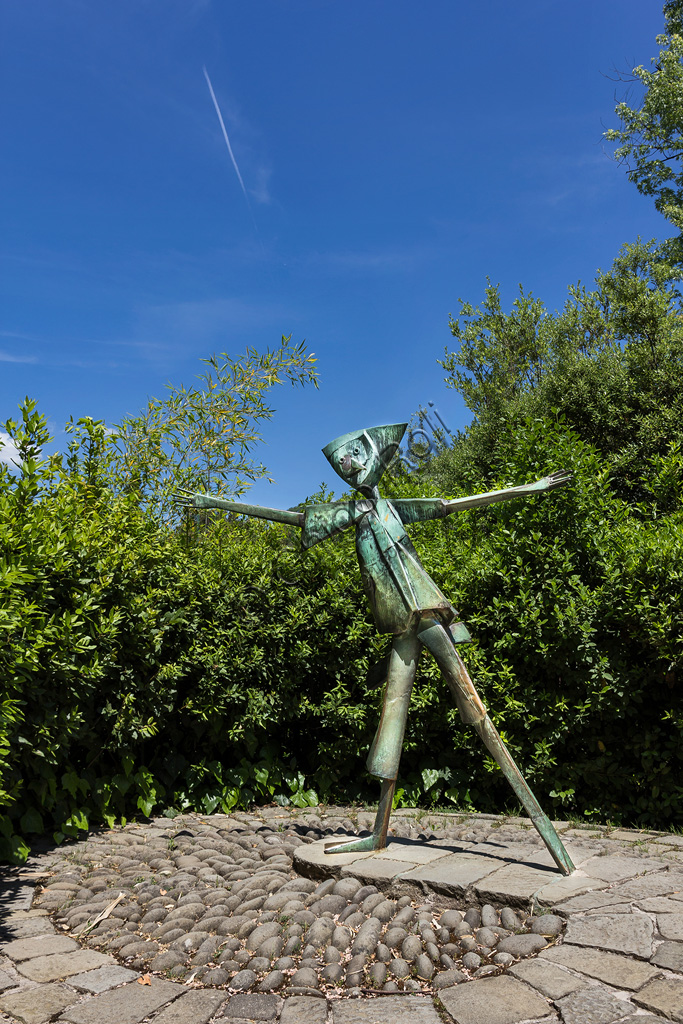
325,629 -> 421,853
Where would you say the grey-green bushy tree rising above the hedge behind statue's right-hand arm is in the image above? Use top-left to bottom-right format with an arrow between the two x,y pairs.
432,242 -> 683,511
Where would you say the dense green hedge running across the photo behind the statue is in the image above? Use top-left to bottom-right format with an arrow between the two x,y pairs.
0,408 -> 683,859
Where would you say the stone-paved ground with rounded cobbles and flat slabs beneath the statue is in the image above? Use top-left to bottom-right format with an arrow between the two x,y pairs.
0,807 -> 683,1024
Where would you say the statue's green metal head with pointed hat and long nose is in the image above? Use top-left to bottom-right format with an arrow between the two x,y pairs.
323,423 -> 408,495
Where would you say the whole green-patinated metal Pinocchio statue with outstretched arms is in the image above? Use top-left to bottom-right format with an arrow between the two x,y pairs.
176,423 -> 573,874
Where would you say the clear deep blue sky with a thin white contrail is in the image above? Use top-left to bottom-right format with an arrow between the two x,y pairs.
0,0 -> 670,507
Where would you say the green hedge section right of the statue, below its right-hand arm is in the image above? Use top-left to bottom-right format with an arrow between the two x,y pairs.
428,420 -> 683,827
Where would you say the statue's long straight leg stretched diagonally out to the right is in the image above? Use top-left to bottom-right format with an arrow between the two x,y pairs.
419,620 -> 574,874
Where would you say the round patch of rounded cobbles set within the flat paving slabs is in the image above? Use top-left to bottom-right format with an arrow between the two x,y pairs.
34,809 -> 562,995
